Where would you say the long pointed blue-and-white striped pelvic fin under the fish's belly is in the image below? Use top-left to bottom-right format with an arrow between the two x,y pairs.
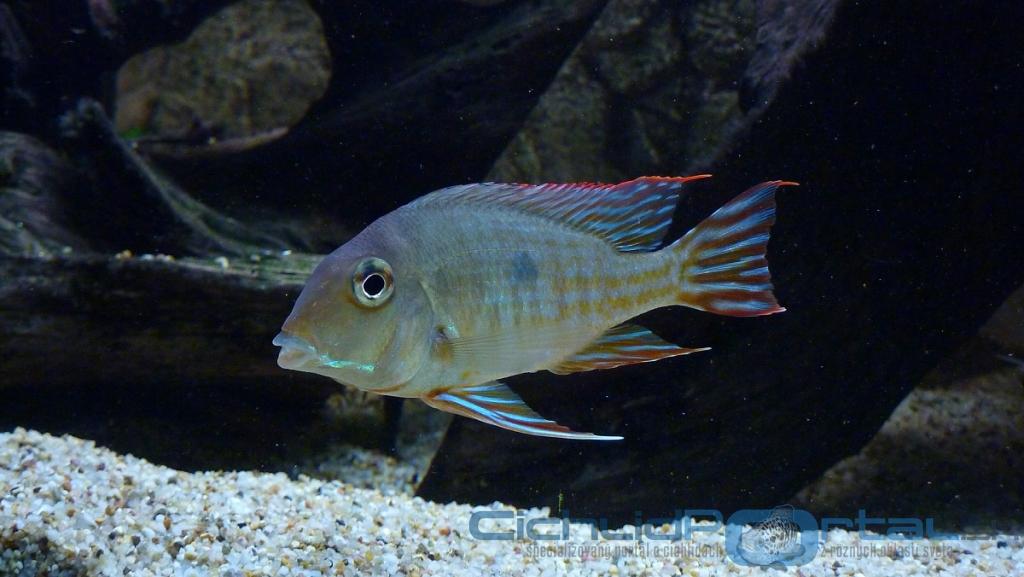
423,381 -> 623,441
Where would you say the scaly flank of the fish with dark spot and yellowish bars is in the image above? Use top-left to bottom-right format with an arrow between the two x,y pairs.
403,201 -> 677,342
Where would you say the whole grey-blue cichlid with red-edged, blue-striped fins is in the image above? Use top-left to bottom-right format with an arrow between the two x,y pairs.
273,174 -> 796,441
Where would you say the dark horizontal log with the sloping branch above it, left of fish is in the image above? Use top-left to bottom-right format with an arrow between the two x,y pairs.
0,99 -> 321,399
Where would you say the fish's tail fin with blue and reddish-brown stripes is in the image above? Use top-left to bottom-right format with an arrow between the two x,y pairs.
671,180 -> 797,317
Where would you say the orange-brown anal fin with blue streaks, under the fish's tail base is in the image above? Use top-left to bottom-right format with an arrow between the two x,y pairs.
548,323 -> 708,375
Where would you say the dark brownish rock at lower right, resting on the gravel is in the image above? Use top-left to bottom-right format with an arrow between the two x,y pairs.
788,325 -> 1024,534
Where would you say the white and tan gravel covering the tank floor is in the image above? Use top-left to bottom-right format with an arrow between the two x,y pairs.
0,429 -> 1024,577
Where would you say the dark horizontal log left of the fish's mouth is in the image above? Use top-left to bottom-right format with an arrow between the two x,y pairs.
0,254 -> 319,387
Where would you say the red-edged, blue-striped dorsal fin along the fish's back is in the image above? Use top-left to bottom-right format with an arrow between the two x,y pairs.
409,174 -> 711,252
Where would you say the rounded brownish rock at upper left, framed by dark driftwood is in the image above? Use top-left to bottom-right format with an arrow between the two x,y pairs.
115,0 -> 331,143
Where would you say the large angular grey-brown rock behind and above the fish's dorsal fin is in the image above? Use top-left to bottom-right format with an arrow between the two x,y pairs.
487,0 -> 836,182
